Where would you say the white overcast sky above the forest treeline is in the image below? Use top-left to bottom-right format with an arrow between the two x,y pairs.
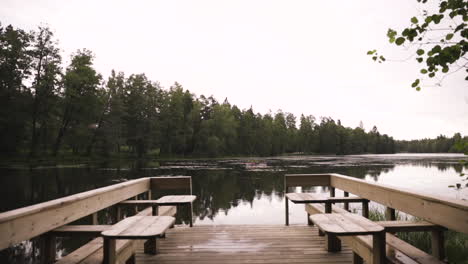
0,0 -> 468,139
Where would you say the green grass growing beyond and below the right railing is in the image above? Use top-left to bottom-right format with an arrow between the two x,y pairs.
369,208 -> 468,264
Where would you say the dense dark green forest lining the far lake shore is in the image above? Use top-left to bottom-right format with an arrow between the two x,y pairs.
0,24 -> 468,158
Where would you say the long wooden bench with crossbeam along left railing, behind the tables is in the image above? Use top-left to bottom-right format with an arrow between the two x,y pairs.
52,206 -> 177,264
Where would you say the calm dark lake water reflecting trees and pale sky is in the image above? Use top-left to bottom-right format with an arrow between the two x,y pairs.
0,154 -> 468,263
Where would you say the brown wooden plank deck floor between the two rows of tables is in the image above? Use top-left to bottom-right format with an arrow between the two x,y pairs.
136,225 -> 352,264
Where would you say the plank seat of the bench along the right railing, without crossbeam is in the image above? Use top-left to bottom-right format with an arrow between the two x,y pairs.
305,204 -> 444,264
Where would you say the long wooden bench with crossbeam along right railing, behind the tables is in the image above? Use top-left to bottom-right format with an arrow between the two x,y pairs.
305,204 -> 444,264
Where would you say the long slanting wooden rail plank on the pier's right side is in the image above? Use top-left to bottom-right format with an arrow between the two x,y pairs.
330,174 -> 468,234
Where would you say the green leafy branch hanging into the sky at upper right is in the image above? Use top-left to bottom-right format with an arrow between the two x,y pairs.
367,0 -> 468,91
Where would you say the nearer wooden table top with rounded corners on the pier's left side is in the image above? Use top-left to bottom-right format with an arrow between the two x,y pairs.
101,216 -> 175,239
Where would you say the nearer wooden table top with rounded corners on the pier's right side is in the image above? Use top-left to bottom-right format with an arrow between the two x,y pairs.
310,213 -> 384,236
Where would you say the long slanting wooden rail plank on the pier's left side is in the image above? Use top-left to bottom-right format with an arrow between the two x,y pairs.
0,178 -> 150,249
